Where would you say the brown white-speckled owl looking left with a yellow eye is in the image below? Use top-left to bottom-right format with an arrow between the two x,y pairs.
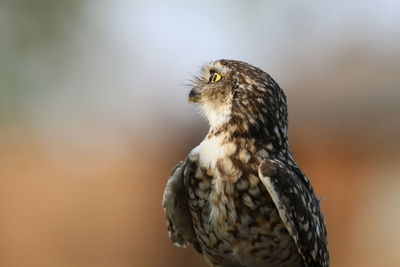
162,59 -> 329,267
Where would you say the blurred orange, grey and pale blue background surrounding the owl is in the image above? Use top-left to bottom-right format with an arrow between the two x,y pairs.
0,0 -> 400,267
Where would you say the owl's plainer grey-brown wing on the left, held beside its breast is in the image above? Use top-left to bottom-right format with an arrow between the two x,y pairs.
162,160 -> 201,252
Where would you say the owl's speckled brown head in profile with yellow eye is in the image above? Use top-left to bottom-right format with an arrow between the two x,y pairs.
189,59 -> 287,144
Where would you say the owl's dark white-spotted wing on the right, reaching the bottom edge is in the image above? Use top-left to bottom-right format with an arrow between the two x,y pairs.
258,159 -> 329,267
